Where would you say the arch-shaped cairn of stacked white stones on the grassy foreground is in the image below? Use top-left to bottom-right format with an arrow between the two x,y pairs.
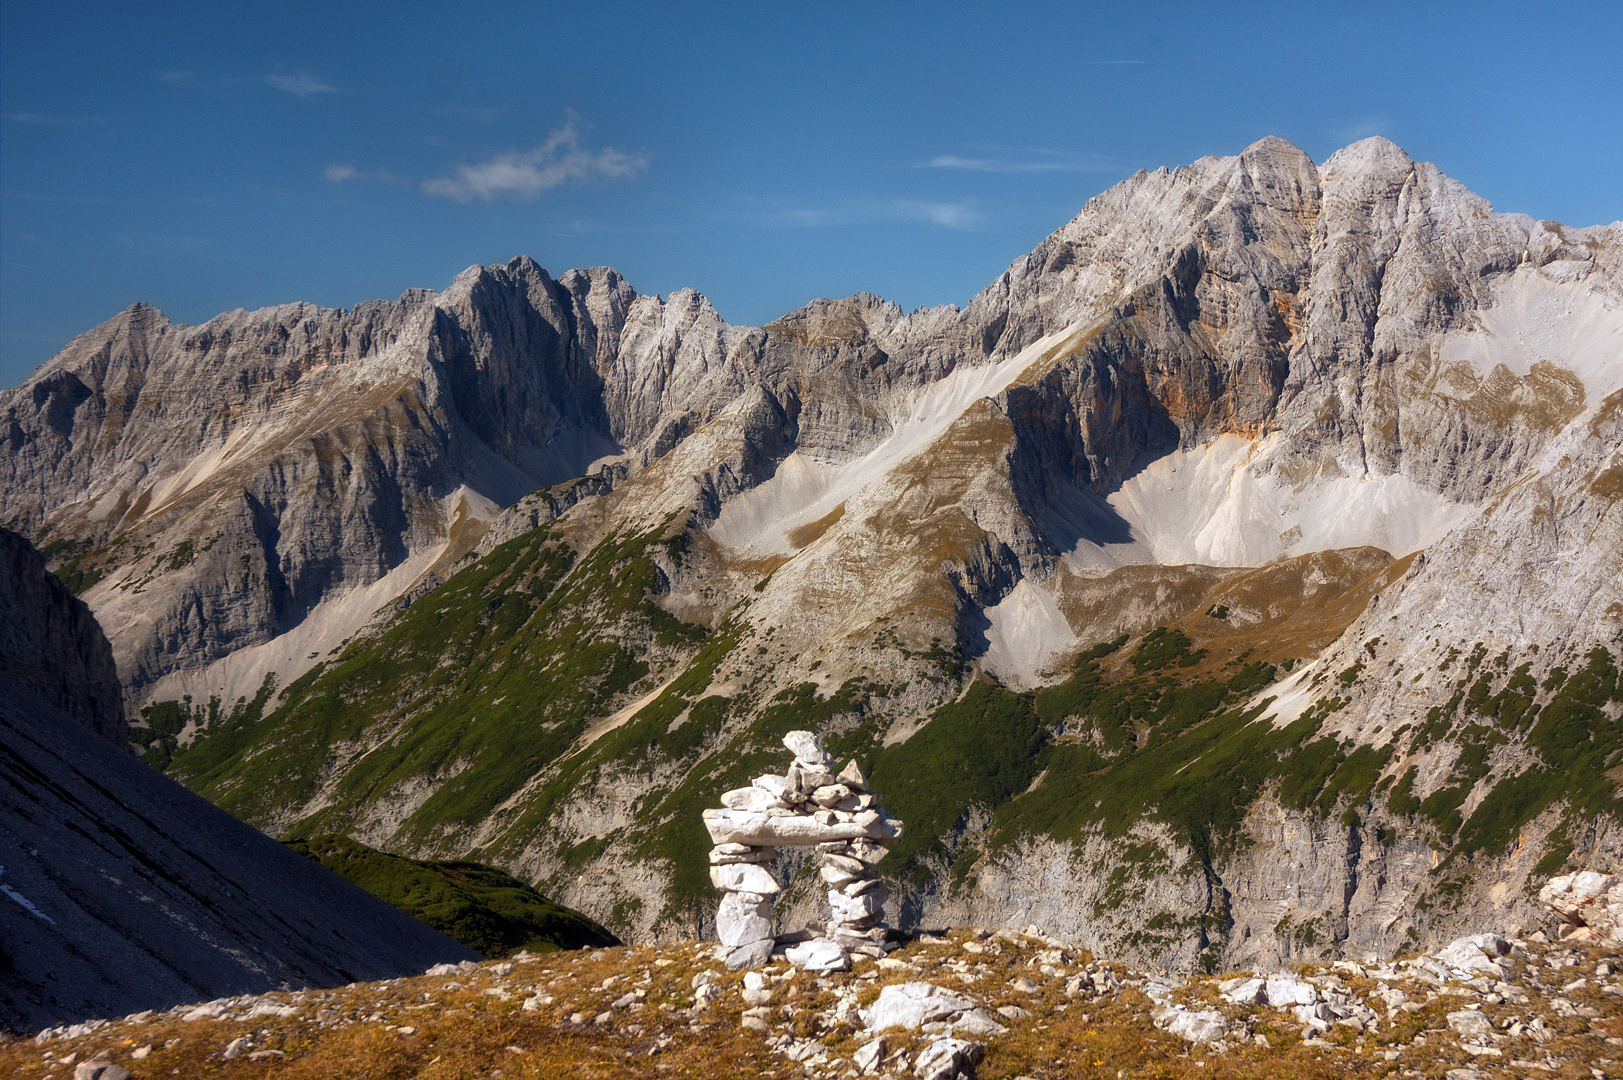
704,731 -> 902,971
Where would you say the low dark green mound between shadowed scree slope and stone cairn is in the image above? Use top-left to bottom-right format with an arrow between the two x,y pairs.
287,836 -> 620,958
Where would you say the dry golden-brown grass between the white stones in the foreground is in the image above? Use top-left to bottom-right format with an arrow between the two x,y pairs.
0,932 -> 1623,1080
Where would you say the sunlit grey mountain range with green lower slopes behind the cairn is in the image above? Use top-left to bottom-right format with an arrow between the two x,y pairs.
0,138 -> 1623,965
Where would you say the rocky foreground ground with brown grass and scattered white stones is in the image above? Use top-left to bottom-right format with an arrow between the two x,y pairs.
0,929 -> 1623,1080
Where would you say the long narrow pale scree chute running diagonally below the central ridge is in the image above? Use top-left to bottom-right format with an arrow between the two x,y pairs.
709,323 -> 1087,557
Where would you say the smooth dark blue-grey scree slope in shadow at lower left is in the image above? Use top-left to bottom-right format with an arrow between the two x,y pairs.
0,529 -> 476,1031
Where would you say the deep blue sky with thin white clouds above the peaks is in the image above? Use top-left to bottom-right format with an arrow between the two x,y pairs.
0,0 -> 1623,387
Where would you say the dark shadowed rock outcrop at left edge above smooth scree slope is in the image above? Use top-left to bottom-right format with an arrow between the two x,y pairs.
0,529 -> 127,745
